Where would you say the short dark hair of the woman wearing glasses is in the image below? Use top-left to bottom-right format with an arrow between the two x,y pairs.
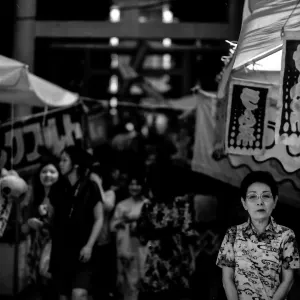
240,171 -> 278,199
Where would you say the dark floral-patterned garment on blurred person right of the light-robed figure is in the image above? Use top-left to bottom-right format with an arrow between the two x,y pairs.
137,196 -> 197,293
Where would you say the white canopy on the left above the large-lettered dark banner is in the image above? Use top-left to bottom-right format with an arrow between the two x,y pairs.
0,55 -> 79,107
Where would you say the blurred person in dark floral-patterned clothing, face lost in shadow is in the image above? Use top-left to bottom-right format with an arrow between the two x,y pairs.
137,164 -> 197,300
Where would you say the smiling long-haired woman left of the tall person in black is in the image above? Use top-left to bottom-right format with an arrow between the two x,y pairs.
22,156 -> 64,299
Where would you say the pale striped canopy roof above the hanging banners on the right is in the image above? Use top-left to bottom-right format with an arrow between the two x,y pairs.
233,0 -> 300,70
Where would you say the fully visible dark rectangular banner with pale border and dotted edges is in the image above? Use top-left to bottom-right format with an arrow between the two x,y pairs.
225,80 -> 270,155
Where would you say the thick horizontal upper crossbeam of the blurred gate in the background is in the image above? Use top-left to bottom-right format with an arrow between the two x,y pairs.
36,21 -> 231,40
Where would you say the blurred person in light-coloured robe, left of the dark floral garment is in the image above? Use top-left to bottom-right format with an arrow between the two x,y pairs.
111,176 -> 147,300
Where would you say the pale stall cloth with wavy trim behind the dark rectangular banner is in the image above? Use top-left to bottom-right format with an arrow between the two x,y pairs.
192,99 -> 300,207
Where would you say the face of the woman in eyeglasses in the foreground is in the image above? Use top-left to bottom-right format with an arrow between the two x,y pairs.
242,182 -> 278,220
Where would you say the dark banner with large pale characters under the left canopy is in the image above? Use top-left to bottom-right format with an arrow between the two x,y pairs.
0,105 -> 84,171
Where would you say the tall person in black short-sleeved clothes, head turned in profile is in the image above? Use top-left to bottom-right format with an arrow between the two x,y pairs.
51,146 -> 103,300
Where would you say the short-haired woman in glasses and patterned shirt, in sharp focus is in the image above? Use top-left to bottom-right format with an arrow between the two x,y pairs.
217,171 -> 300,300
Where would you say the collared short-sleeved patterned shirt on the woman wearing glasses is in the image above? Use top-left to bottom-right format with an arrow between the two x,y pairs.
217,218 -> 300,300
